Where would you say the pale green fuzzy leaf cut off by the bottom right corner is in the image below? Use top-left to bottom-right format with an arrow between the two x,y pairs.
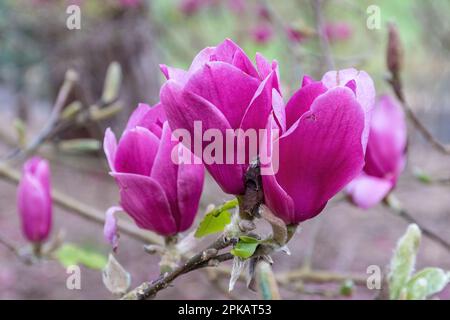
406,268 -> 450,300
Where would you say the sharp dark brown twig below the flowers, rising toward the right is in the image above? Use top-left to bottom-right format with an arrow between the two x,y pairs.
122,236 -> 233,300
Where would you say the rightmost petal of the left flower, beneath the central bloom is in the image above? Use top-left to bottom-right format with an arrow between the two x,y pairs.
177,144 -> 205,232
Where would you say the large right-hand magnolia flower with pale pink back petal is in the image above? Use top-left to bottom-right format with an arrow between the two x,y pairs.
262,69 -> 375,224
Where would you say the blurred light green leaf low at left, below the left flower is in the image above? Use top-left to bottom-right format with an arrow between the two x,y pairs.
56,243 -> 108,270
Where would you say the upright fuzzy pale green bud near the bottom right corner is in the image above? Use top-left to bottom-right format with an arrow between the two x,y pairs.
388,224 -> 421,300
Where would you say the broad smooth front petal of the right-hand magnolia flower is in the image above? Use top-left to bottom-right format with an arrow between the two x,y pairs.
276,88 -> 364,223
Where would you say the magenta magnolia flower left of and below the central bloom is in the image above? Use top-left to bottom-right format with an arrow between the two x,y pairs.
104,104 -> 204,236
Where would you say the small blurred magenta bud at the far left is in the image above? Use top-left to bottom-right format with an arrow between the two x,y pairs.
17,157 -> 52,243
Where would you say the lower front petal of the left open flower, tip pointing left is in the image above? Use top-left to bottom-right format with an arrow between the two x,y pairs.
112,173 -> 177,236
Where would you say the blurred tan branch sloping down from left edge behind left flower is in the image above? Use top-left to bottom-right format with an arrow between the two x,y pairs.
0,164 -> 164,245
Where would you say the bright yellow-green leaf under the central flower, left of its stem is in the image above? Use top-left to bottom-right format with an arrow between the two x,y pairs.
195,199 -> 238,238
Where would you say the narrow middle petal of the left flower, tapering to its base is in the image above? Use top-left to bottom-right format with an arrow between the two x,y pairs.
150,122 -> 180,225
